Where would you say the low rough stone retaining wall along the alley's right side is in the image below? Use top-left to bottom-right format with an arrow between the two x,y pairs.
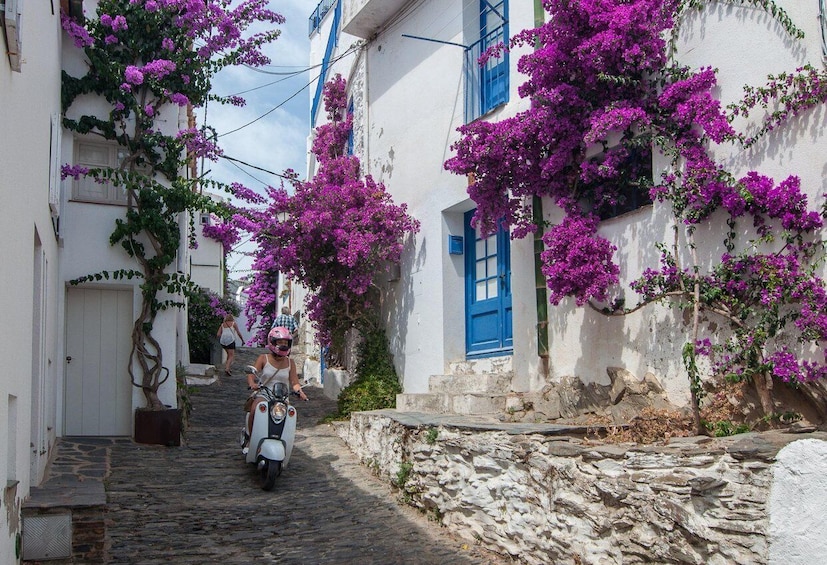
339,411 -> 827,564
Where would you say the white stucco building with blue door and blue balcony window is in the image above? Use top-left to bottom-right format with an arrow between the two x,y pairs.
308,0 -> 827,411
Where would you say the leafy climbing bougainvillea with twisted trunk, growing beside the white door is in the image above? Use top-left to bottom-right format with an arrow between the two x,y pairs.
61,0 -> 283,409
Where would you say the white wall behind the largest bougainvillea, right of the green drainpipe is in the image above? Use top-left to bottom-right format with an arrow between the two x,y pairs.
548,0 -> 827,404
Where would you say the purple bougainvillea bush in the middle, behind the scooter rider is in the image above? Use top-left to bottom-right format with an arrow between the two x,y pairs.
241,76 -> 419,356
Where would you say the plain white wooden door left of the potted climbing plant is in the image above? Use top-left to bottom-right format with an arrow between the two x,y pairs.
65,288 -> 133,436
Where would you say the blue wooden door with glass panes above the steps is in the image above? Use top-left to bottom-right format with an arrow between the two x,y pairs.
465,210 -> 514,357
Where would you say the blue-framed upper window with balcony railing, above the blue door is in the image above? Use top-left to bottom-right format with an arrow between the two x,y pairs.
465,0 -> 509,123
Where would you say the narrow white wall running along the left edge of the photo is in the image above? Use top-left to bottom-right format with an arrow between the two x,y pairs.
0,2 -> 61,563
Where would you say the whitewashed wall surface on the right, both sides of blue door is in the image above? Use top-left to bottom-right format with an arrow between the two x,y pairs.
310,0 -> 826,404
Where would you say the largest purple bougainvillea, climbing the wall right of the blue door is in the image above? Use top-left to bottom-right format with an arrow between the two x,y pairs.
445,0 -> 827,430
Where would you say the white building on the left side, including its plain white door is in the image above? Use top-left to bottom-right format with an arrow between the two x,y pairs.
0,4 -> 223,563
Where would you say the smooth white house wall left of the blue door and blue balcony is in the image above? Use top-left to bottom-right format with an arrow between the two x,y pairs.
311,0 -> 536,393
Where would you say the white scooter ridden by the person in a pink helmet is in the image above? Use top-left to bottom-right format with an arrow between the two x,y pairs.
241,365 -> 296,490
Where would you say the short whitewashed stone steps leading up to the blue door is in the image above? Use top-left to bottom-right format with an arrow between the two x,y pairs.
396,357 -> 514,415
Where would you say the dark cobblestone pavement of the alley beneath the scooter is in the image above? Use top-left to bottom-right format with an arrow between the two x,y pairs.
106,348 -> 510,564
